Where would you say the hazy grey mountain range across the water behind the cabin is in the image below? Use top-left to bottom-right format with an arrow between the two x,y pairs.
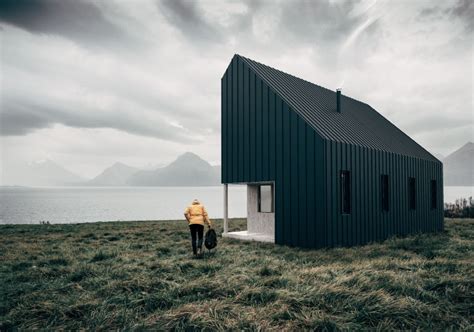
2,142 -> 474,186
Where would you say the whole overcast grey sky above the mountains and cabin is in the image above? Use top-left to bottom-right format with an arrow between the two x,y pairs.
0,0 -> 474,177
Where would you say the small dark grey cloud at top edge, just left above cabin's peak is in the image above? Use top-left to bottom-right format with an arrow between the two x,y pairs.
157,0 -> 222,42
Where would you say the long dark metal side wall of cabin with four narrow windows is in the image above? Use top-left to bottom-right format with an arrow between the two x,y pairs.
325,141 -> 443,247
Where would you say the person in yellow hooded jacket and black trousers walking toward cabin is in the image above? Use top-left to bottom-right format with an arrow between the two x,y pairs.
184,199 -> 212,256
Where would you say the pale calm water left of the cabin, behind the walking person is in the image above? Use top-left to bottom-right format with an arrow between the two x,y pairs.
0,186 -> 247,224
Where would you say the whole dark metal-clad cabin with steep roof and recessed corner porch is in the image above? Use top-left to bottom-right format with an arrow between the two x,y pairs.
221,55 -> 443,248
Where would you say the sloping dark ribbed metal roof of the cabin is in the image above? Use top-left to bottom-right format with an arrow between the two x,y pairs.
236,55 -> 437,161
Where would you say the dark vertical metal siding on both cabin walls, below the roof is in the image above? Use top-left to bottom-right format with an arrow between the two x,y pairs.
221,57 -> 443,248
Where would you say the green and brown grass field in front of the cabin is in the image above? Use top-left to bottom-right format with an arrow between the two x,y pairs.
0,220 -> 474,330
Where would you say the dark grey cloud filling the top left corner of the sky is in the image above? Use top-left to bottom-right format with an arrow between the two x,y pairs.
0,0 -> 135,48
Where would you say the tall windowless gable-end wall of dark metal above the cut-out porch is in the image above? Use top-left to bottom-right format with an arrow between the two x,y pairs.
221,57 -> 326,248
